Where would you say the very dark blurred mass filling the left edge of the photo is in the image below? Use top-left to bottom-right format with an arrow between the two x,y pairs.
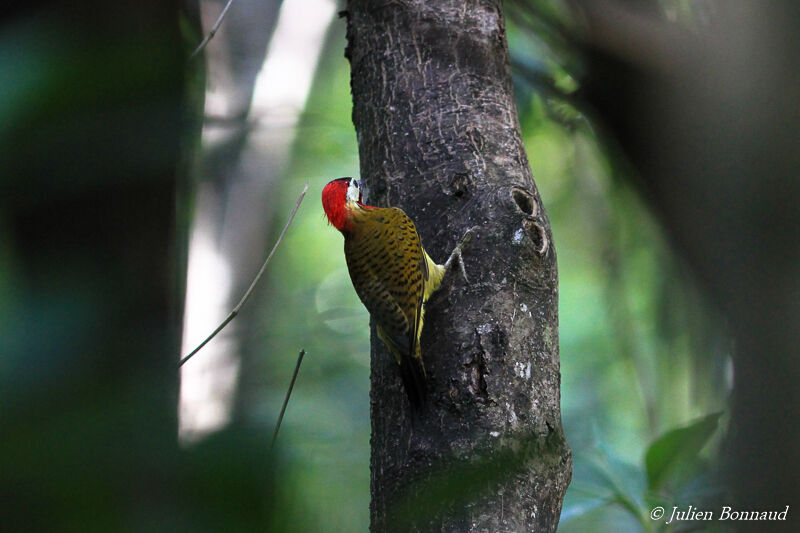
0,1 -> 191,531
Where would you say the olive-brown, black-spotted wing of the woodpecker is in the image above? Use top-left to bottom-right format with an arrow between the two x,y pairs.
345,207 -> 427,357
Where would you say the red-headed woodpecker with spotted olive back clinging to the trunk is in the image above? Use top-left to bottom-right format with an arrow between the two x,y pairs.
322,178 -> 474,411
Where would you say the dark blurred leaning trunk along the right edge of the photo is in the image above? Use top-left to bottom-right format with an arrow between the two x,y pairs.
560,0 -> 800,531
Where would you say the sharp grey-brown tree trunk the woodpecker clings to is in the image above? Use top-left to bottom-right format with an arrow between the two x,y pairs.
347,0 -> 572,532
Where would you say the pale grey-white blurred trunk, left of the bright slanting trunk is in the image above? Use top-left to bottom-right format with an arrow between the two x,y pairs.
179,0 -> 284,442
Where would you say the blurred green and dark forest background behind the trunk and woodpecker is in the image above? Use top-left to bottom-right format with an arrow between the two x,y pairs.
0,0 -> 800,531
